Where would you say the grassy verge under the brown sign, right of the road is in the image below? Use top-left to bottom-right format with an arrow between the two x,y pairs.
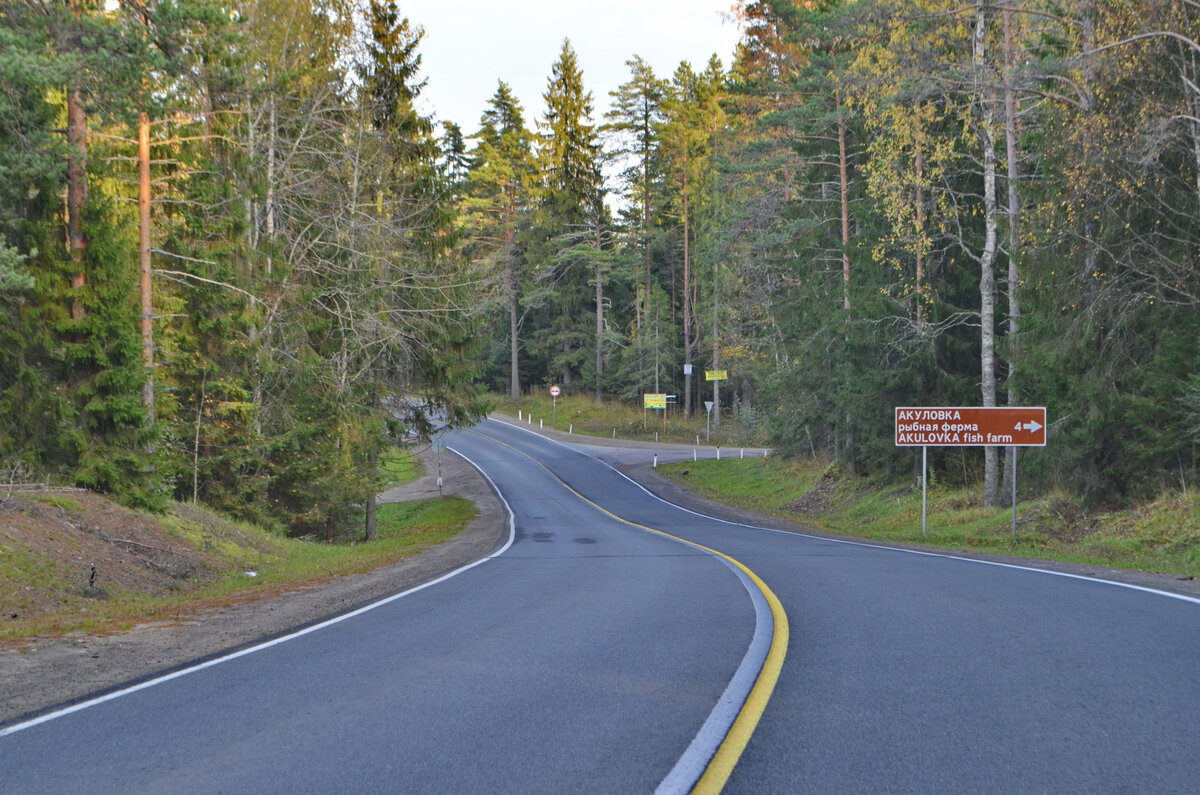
659,458 -> 1200,576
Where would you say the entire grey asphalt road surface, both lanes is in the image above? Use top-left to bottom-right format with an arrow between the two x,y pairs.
0,422 -> 1200,793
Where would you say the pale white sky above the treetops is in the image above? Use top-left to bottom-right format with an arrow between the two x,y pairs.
397,0 -> 738,136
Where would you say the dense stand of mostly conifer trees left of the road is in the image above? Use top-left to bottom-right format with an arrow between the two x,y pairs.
0,0 -> 481,537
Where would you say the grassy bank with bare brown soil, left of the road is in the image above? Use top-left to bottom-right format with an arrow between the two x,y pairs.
0,456 -> 478,641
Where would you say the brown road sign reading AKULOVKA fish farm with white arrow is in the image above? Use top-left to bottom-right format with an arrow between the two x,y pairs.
895,406 -> 1046,447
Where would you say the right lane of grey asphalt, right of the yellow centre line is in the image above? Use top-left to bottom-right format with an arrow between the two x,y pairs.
472,425 -> 1200,793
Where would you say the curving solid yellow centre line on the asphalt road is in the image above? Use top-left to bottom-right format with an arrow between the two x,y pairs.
474,431 -> 788,795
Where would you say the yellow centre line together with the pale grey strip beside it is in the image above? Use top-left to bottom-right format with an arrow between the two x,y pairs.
470,431 -> 788,795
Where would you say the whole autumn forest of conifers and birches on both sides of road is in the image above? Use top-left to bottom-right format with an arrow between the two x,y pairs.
0,0 -> 1200,538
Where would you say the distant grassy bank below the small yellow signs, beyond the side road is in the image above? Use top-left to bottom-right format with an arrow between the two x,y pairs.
493,391 -> 766,447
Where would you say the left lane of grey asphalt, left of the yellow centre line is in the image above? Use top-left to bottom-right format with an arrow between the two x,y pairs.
0,420 -> 757,793
